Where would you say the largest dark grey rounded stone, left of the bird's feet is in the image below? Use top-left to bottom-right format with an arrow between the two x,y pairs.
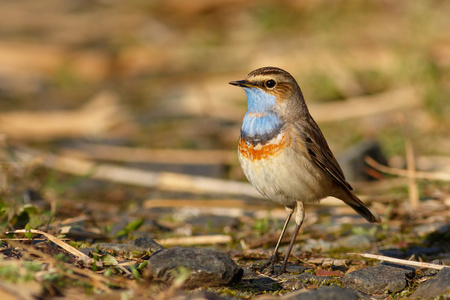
148,247 -> 244,289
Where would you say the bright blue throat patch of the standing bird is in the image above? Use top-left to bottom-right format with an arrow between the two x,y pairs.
241,87 -> 283,144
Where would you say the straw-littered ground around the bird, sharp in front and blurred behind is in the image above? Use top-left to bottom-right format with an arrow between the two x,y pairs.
0,0 -> 450,299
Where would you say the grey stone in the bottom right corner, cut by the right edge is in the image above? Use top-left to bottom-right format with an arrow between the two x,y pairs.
411,268 -> 450,298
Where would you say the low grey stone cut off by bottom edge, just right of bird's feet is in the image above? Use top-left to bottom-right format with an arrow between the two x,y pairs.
280,285 -> 358,300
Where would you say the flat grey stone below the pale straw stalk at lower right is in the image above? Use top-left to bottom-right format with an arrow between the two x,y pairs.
342,264 -> 414,294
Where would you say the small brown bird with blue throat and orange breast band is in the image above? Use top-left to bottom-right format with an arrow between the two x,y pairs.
230,67 -> 381,273
